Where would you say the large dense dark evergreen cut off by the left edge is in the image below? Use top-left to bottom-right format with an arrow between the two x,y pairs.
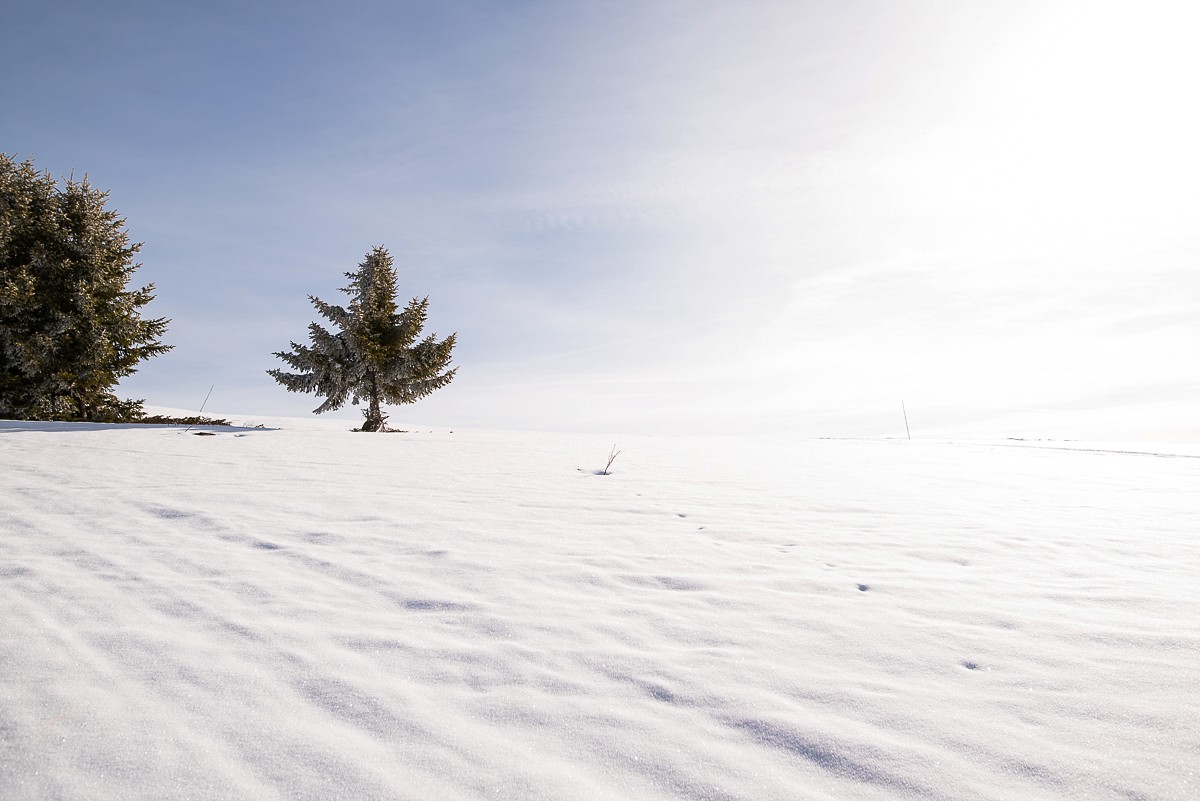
0,153 -> 170,420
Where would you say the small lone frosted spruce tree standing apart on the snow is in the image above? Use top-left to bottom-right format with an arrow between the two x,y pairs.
268,247 -> 457,432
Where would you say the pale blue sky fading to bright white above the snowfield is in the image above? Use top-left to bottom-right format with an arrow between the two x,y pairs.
0,0 -> 1200,439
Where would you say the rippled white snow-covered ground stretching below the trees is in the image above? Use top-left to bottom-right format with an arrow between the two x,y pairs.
0,421 -> 1200,801
